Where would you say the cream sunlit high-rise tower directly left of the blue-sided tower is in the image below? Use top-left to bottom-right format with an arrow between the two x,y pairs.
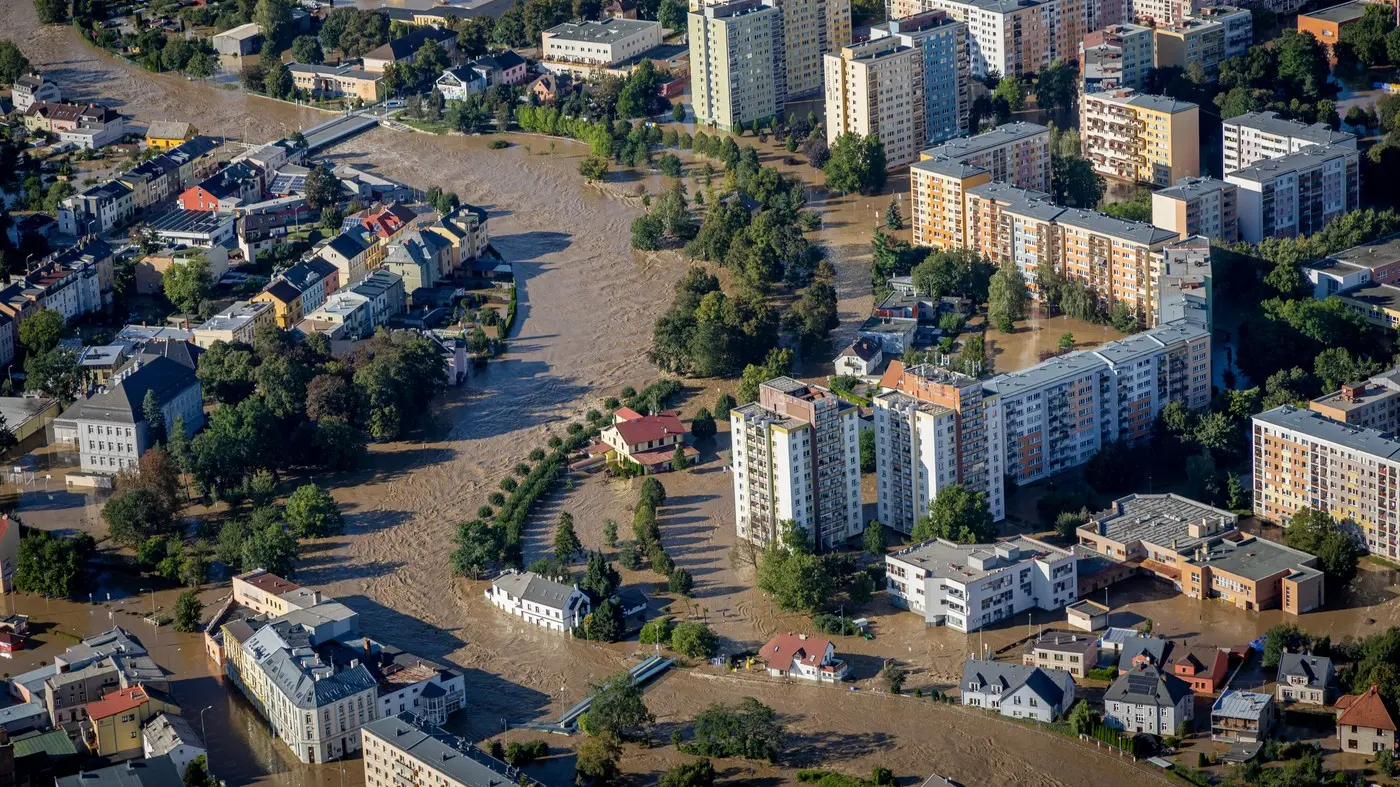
823,38 -> 927,169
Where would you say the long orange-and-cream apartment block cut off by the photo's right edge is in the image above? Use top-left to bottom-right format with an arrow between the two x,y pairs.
1253,405 -> 1400,560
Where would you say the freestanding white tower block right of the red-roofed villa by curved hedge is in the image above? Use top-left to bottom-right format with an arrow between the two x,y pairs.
729,377 -> 864,549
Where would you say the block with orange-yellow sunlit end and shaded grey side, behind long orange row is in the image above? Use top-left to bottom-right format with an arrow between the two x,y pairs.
909,123 -> 1050,249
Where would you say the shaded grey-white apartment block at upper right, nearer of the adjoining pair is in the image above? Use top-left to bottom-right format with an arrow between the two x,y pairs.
1225,144 -> 1361,244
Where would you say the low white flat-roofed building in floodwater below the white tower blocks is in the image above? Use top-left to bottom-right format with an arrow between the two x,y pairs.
885,536 -> 1079,633
